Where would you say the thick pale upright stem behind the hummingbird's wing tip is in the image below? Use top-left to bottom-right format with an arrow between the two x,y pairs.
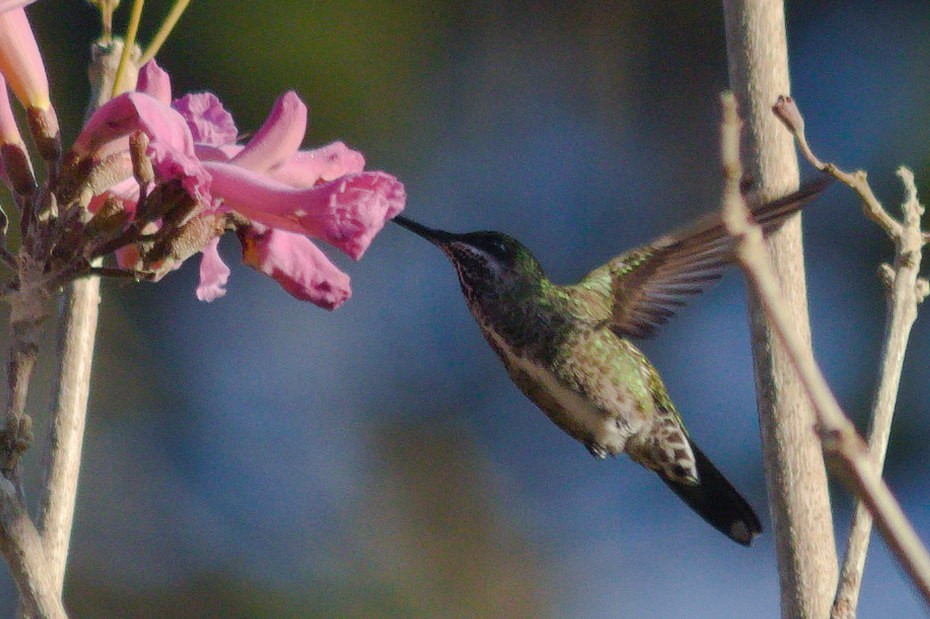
723,0 -> 838,619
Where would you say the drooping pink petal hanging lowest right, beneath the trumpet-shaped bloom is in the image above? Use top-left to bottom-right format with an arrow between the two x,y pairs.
241,226 -> 352,310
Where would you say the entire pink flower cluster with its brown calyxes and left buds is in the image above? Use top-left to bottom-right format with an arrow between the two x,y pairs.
0,0 -> 406,309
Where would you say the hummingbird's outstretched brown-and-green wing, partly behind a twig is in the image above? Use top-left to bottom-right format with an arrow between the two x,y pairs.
572,176 -> 832,338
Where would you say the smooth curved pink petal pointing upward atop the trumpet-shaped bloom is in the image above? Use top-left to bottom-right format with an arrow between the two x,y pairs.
233,91 -> 307,172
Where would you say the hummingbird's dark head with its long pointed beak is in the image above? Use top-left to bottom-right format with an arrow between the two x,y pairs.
394,216 -> 544,296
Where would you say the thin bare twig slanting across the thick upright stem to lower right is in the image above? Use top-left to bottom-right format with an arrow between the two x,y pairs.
722,92 -> 930,605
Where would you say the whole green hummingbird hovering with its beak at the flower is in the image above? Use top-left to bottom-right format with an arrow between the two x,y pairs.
393,177 -> 830,546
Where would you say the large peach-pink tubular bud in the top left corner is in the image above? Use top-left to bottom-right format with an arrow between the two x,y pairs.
0,6 -> 52,110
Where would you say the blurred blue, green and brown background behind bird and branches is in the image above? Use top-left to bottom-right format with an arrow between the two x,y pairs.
0,0 -> 930,618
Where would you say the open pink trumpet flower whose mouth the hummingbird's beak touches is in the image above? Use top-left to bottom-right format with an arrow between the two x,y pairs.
186,92 -> 406,260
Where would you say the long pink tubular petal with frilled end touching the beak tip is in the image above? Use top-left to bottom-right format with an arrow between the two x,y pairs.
204,162 -> 406,260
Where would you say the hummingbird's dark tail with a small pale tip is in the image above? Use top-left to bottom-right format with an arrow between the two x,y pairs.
659,442 -> 762,546
